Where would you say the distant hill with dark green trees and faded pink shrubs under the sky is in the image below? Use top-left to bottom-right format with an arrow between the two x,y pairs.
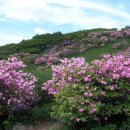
0,28 -> 130,59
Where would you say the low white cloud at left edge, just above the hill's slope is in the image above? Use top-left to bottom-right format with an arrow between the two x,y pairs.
0,33 -> 30,46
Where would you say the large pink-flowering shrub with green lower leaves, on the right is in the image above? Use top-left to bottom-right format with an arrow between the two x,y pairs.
43,54 -> 130,127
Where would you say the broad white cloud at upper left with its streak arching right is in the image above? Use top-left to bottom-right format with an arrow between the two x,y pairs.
0,0 -> 130,22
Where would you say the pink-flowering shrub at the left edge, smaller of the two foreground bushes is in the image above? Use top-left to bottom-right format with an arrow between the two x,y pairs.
0,57 -> 37,114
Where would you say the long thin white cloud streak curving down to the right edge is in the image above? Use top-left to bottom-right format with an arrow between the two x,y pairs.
45,0 -> 130,19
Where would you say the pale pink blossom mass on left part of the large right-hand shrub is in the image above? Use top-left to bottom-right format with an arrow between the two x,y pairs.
42,58 -> 89,94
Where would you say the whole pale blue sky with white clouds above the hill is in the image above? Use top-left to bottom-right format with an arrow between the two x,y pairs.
0,0 -> 130,46
